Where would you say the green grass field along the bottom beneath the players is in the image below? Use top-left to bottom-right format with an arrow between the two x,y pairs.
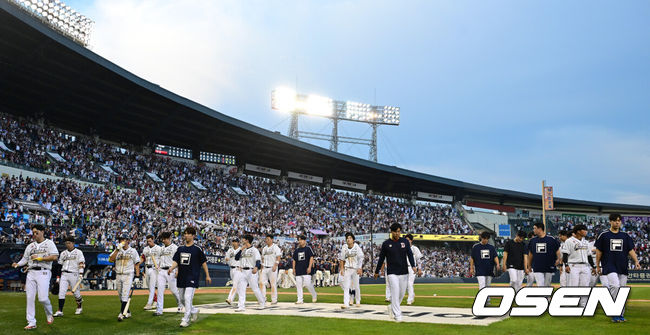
0,284 -> 650,335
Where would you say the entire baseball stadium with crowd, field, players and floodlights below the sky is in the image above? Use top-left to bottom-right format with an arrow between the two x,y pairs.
0,0 -> 650,335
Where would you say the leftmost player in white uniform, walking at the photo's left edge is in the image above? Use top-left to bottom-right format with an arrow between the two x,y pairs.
12,224 -> 59,329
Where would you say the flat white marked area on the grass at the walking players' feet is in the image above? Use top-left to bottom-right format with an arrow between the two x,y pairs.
159,302 -> 504,326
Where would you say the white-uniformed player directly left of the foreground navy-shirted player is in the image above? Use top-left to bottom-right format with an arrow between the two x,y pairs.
154,232 -> 183,316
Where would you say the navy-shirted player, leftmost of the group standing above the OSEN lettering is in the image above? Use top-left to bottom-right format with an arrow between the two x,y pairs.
469,231 -> 499,303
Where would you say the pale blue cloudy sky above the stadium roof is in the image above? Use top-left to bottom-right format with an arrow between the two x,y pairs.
66,0 -> 650,205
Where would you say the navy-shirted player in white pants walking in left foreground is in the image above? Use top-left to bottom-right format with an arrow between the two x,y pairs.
167,227 -> 212,327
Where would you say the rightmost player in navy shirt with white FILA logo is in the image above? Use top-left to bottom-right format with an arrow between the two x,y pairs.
595,214 -> 641,322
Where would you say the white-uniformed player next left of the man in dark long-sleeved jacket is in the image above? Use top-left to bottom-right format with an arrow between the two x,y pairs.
339,233 -> 363,309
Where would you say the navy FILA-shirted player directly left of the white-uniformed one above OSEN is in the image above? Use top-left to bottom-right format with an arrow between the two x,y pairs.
528,222 -> 562,286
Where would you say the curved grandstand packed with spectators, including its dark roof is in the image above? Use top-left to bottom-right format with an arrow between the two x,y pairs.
0,1 -> 650,294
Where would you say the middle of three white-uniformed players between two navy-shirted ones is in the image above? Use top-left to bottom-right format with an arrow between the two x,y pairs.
235,235 -> 266,312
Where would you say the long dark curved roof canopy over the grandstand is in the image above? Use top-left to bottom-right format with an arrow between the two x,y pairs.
0,1 -> 650,214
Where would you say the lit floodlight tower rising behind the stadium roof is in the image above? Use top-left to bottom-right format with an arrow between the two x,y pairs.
271,87 -> 400,162
